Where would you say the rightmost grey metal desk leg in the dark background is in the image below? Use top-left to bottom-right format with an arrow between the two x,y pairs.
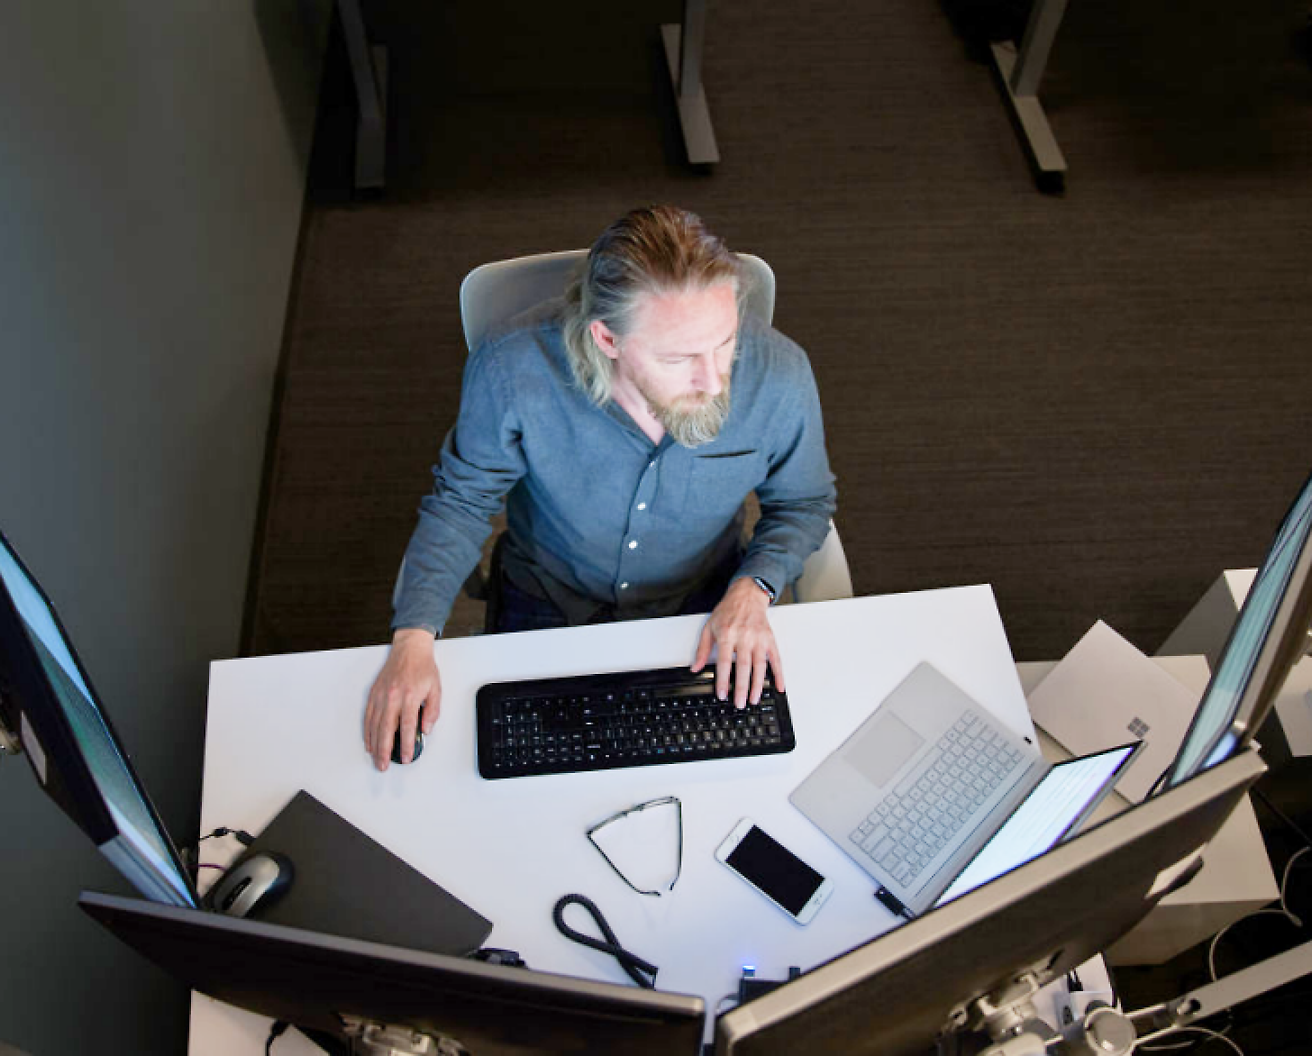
991,0 -> 1067,190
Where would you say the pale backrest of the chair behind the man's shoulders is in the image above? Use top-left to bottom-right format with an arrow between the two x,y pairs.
461,249 -> 774,350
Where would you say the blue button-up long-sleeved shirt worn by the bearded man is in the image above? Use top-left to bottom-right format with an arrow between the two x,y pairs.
392,300 -> 834,632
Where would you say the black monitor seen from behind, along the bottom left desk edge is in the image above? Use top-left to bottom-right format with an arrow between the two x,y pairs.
79,892 -> 706,1056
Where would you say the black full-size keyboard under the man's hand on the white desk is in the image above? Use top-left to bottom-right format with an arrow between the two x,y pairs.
478,668 -> 796,779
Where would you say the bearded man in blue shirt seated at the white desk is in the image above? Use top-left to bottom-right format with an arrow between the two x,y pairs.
365,206 -> 834,770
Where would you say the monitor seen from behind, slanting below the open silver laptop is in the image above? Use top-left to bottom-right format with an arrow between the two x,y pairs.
715,750 -> 1265,1056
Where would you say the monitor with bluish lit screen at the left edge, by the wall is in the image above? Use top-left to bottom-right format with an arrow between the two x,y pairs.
0,533 -> 197,906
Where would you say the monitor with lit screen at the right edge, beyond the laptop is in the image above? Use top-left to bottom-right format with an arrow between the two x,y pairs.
1164,477 -> 1312,788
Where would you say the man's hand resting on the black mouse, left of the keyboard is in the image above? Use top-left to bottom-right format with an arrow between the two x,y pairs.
365,627 -> 442,770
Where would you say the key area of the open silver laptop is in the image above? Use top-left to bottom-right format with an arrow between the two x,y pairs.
849,714 -> 1021,884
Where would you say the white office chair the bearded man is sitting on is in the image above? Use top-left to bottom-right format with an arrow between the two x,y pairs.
440,249 -> 851,627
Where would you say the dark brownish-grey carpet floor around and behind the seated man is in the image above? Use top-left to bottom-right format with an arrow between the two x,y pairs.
245,0 -> 1312,659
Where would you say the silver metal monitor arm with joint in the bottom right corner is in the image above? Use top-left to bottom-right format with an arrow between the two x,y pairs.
950,942 -> 1312,1056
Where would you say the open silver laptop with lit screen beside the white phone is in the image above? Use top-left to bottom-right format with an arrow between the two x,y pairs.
790,664 -> 1140,918
